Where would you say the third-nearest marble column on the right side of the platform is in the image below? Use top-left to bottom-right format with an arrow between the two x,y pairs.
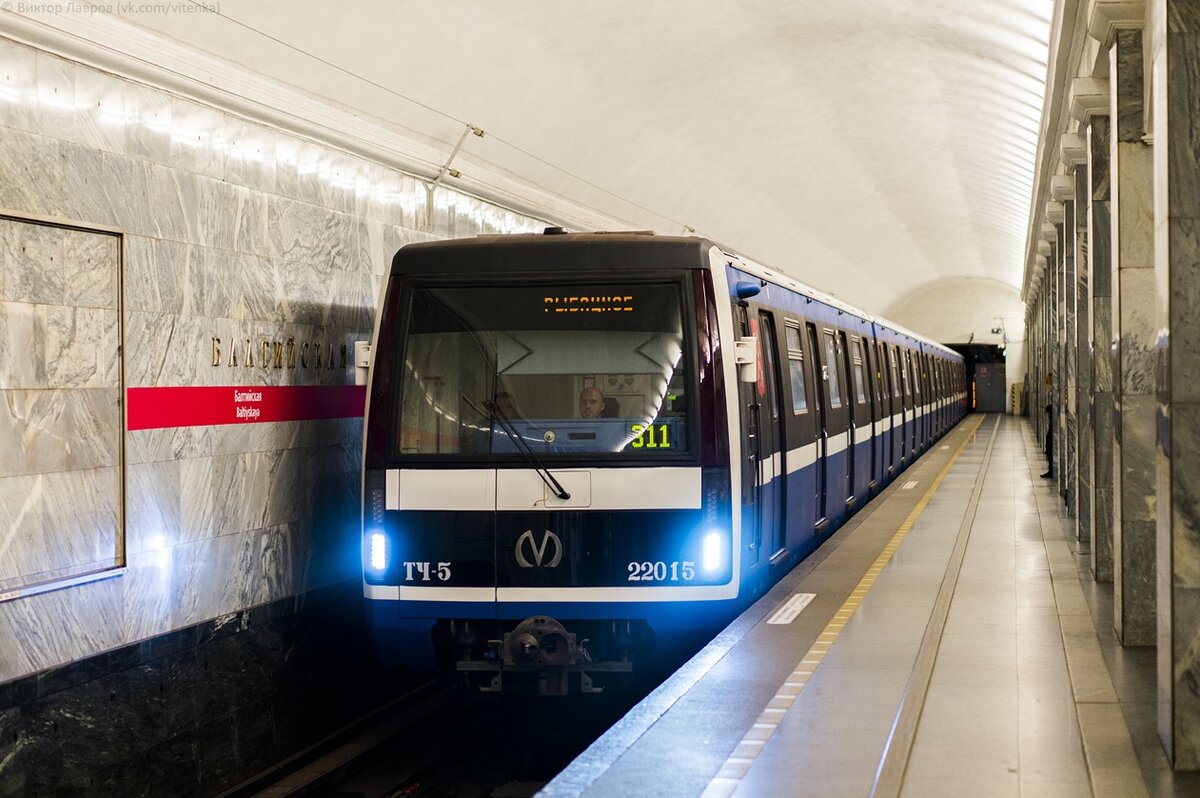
1087,116 -> 1112,582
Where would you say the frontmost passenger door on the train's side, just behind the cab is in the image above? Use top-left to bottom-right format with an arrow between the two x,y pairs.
755,310 -> 787,557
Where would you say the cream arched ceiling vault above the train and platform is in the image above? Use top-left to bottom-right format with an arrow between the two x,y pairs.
82,0 -> 1052,343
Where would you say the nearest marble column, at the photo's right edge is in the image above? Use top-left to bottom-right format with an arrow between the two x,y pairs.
1150,0 -> 1200,770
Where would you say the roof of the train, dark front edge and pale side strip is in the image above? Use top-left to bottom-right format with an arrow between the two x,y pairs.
392,228 -> 955,355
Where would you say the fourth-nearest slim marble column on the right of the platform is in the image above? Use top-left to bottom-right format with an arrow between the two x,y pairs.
1069,160 -> 1092,552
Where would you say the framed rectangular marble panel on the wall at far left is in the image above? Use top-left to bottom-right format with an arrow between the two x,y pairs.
0,217 -> 124,596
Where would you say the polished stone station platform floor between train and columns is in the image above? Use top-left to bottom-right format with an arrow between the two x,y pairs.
539,414 -> 1200,798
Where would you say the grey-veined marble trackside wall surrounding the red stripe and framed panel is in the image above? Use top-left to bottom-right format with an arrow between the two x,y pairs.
0,29 -> 544,782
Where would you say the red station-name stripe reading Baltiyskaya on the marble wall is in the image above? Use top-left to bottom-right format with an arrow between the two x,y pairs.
126,385 -> 366,430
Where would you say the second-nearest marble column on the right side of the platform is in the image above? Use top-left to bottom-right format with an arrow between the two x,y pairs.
1109,30 -> 1157,646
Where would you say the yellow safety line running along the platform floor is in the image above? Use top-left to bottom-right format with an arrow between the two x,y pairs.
702,414 -> 984,798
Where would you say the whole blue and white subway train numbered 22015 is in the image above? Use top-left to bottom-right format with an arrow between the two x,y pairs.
362,228 -> 967,694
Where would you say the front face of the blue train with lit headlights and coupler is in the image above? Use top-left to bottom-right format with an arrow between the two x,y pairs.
362,234 -> 739,694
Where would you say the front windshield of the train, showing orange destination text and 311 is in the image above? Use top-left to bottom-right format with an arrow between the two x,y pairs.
395,282 -> 691,460
